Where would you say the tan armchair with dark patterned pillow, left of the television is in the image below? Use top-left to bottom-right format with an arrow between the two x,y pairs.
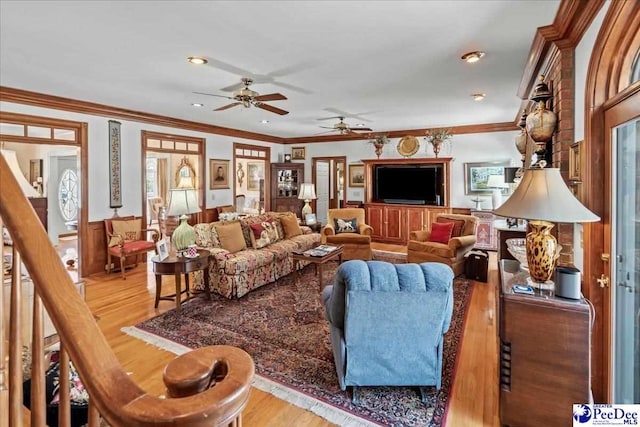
322,208 -> 373,260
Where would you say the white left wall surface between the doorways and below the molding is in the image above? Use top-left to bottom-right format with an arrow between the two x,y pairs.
0,102 -> 283,221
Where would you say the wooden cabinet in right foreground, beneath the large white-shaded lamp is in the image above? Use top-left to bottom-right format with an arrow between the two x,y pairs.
498,260 -> 591,427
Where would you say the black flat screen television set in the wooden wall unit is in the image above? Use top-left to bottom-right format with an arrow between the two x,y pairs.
373,164 -> 445,206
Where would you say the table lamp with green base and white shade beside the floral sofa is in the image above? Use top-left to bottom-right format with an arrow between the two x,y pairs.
167,188 -> 200,253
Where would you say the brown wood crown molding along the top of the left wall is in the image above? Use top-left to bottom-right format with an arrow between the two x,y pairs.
0,86 -> 283,144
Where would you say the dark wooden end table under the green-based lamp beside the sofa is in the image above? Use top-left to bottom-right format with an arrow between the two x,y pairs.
151,249 -> 211,313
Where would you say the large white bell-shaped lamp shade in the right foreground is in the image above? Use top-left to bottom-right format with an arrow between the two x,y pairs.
494,168 -> 600,223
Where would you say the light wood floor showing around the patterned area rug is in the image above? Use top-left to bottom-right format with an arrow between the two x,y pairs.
81,244 -> 499,427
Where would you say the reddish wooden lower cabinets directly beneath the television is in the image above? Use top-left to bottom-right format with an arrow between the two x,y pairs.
365,203 -> 450,245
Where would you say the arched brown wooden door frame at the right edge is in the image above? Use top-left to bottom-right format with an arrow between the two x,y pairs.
582,2 -> 640,403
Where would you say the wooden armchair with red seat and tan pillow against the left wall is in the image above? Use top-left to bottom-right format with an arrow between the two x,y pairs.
104,216 -> 160,280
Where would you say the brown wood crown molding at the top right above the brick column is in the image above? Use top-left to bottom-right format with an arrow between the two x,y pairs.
517,0 -> 605,99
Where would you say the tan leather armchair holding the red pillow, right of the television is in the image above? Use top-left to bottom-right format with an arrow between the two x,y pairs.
407,214 -> 478,276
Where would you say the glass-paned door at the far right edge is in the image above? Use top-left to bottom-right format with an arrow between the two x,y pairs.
605,92 -> 640,404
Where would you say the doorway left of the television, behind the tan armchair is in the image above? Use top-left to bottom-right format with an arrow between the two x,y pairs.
311,156 -> 347,224
